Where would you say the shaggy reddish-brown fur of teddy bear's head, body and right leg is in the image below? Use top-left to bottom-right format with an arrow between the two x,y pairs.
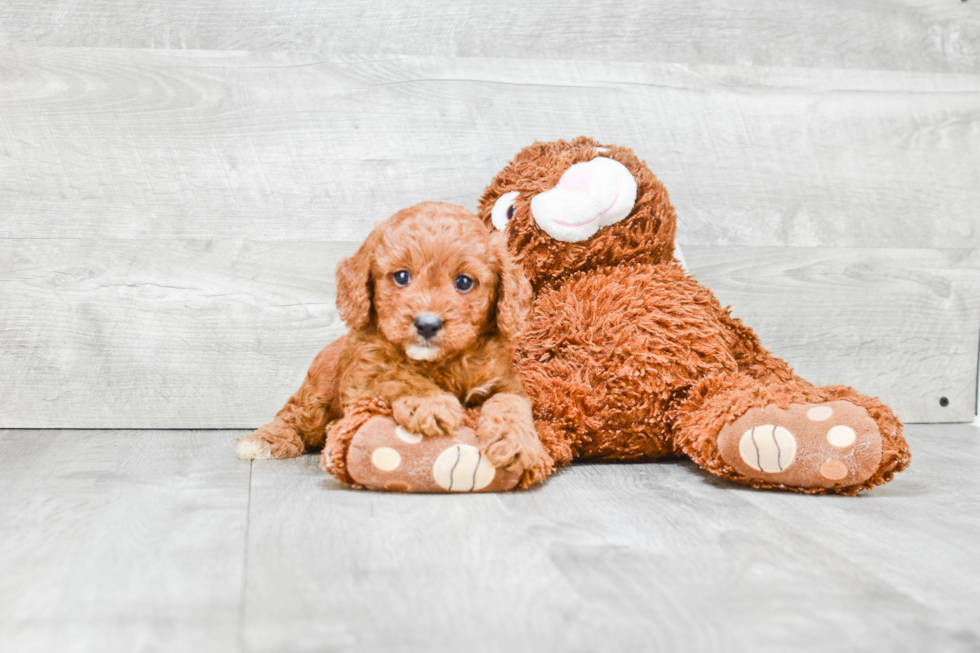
479,137 -> 909,494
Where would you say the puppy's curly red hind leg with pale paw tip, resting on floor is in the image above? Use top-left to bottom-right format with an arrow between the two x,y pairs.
238,338 -> 343,460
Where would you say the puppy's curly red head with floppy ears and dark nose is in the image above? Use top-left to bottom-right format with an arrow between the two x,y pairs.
337,202 -> 530,361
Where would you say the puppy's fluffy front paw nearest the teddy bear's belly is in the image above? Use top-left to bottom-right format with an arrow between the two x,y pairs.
476,392 -> 543,472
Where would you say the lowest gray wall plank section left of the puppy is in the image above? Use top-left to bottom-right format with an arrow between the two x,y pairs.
0,240 -> 357,428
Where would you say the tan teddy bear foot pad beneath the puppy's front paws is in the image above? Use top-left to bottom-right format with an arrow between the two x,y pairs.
347,416 -> 520,492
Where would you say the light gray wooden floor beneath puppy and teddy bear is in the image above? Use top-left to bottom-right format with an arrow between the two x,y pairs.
0,424 -> 980,652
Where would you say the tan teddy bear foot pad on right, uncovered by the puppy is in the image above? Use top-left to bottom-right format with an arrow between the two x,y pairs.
718,401 -> 882,489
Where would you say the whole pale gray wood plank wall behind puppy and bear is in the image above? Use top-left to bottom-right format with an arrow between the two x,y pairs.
0,0 -> 980,428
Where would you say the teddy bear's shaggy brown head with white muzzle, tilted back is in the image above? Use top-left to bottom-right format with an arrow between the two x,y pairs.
479,136 -> 677,290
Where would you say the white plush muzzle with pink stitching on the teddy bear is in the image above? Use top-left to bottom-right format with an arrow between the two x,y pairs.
531,157 -> 636,243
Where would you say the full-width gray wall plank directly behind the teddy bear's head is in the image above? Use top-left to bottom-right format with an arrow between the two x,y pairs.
0,48 -> 980,248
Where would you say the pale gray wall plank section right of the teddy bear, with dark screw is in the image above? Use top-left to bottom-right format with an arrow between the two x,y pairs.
684,247 -> 980,422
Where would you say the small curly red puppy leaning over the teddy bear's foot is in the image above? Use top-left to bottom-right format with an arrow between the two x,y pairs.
238,202 -> 542,471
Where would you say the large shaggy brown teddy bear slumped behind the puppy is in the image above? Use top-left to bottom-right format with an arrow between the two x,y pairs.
324,137 -> 910,495
